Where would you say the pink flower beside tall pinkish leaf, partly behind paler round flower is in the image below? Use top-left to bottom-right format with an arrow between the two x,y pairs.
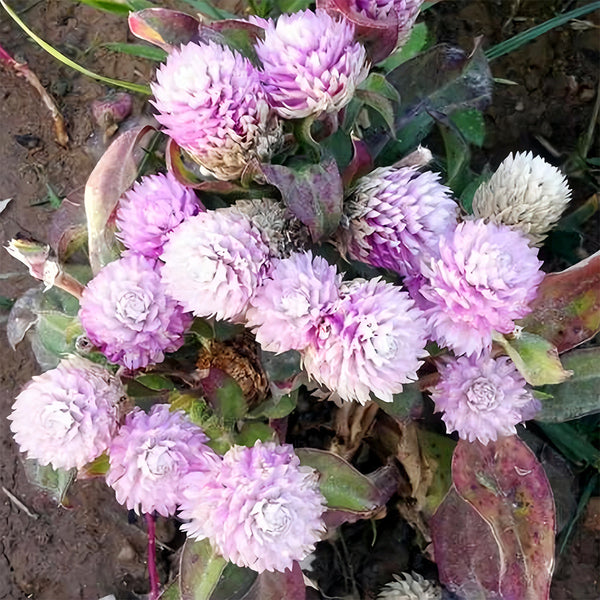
117,173 -> 204,258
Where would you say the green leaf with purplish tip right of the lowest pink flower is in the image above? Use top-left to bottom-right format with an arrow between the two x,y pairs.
296,448 -> 381,513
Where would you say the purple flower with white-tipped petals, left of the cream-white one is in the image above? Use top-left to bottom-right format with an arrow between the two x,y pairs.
337,167 -> 458,275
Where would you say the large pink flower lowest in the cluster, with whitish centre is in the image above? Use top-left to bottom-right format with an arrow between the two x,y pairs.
180,441 -> 325,573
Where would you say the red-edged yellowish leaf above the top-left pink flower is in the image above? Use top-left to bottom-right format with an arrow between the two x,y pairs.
129,8 -> 200,52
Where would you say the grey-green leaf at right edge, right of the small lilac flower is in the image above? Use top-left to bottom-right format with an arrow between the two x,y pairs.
535,347 -> 600,423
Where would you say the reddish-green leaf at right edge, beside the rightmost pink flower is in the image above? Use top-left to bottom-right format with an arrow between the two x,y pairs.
519,252 -> 600,353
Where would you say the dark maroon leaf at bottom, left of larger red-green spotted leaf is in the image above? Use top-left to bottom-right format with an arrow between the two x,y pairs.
429,486 -> 502,600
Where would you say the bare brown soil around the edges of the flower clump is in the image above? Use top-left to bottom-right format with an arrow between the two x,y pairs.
0,0 -> 600,600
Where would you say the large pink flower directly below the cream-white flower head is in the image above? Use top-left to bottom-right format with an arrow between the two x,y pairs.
419,220 -> 544,355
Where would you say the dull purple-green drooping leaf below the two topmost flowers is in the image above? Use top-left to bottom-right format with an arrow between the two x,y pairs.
261,158 -> 344,242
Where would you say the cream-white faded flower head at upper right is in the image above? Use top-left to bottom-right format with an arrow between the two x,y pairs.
473,152 -> 571,246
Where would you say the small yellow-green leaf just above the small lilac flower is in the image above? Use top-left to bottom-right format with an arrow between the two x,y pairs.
493,331 -> 571,386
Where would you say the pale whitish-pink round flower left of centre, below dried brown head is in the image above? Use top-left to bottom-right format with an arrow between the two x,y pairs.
161,209 -> 269,321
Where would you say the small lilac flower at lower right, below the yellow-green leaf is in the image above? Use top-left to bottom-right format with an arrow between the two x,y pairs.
431,355 -> 540,444
